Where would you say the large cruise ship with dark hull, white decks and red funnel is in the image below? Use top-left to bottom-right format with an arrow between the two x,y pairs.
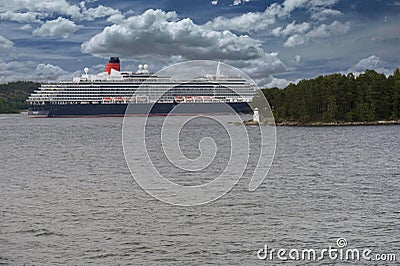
27,57 -> 256,117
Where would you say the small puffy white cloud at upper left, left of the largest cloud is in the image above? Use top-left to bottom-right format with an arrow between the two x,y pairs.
33,17 -> 79,38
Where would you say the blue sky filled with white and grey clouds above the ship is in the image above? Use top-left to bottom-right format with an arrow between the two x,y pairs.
0,0 -> 400,88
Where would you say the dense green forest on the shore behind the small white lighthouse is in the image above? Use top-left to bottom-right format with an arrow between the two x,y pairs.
262,69 -> 400,124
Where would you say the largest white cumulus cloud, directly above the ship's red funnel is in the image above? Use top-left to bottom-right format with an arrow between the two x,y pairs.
81,9 -> 285,82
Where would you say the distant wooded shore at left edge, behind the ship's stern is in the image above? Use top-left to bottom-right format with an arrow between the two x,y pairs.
0,81 -> 40,113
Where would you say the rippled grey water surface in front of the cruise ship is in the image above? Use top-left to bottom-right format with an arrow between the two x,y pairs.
0,115 -> 400,265
